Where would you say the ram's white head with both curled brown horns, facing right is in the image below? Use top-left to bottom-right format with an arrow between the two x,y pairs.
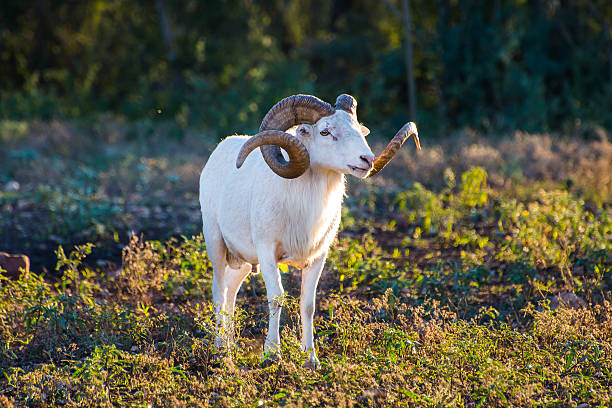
236,94 -> 421,178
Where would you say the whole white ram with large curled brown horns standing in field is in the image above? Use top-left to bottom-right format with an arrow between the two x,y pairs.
200,94 -> 420,368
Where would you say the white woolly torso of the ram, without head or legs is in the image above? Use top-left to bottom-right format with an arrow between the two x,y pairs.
200,136 -> 345,268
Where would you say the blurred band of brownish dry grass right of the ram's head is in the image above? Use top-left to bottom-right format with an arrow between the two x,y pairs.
376,129 -> 612,203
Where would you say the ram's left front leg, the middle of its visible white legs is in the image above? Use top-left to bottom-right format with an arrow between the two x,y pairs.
257,247 -> 284,360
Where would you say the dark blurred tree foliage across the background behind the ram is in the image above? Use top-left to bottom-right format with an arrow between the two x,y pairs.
0,0 -> 612,135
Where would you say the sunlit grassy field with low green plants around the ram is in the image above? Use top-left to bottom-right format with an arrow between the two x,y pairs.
0,121 -> 612,407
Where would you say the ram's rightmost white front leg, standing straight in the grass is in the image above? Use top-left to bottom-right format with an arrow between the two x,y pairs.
300,252 -> 327,370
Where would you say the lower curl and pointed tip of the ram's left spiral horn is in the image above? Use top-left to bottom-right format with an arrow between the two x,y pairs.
236,130 -> 310,179
